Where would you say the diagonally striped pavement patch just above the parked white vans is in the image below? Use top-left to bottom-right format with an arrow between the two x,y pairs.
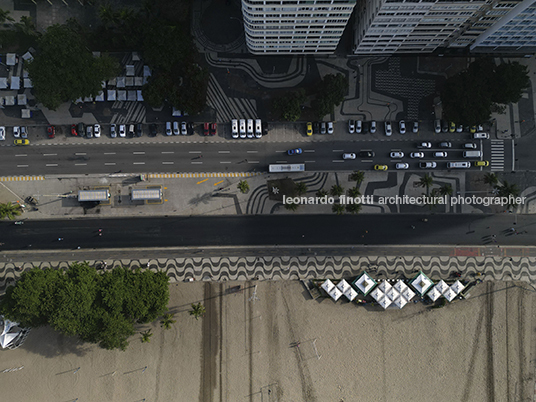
207,74 -> 258,123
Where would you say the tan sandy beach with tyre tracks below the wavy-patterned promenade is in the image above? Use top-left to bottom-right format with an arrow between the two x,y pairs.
0,281 -> 535,402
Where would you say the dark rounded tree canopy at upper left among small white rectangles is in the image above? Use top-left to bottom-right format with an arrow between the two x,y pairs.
28,24 -> 118,110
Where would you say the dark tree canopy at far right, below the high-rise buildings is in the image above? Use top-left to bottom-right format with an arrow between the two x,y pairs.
441,58 -> 529,125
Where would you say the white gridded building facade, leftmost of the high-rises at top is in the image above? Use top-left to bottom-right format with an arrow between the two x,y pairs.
242,0 -> 356,55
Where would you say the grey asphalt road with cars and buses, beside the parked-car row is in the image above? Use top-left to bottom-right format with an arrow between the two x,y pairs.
0,137 -> 504,176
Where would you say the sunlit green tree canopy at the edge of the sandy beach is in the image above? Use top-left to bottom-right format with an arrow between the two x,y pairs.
0,263 -> 169,350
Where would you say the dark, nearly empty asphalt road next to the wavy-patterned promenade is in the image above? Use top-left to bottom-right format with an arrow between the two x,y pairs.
0,214 -> 536,250
